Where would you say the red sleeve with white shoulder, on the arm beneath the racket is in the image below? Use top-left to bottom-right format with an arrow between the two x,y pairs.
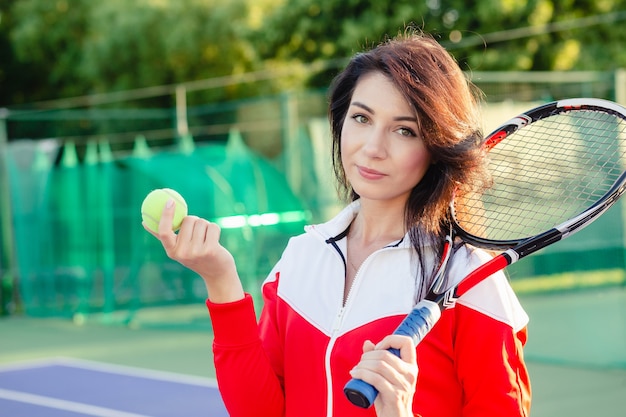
444,245 -> 530,417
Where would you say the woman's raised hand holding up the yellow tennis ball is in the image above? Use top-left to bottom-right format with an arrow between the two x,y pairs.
143,200 -> 244,303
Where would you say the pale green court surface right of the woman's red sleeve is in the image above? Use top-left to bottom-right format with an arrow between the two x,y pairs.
520,286 -> 626,417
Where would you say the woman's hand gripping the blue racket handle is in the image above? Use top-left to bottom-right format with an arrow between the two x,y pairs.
350,335 -> 418,417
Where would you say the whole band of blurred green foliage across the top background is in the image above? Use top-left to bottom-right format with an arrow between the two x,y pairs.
0,0 -> 626,106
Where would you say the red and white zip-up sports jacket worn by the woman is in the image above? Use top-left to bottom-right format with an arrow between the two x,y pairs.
207,201 -> 530,417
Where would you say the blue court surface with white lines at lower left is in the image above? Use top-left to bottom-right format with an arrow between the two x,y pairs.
0,358 -> 228,417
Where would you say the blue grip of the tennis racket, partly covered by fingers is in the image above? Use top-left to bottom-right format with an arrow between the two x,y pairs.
343,300 -> 441,408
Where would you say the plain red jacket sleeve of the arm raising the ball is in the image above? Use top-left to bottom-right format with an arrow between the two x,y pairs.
206,294 -> 285,417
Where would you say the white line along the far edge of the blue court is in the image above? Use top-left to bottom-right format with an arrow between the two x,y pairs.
0,357 -> 217,388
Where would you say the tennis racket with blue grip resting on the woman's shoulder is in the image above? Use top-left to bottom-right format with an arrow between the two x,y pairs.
344,98 -> 626,408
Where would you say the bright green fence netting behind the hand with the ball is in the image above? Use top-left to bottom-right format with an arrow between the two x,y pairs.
3,132 -> 310,322
